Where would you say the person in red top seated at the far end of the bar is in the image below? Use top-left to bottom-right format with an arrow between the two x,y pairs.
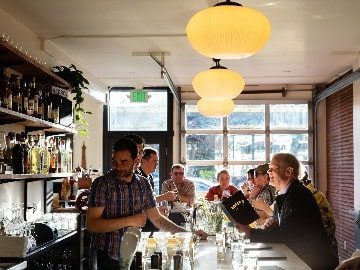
205,170 -> 238,201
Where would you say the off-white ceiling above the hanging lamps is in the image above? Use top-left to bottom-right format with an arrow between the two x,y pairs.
0,0 -> 360,93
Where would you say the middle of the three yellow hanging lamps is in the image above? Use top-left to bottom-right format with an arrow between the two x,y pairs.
192,59 -> 245,99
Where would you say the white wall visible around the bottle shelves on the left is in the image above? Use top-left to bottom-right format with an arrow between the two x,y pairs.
0,9 -> 103,212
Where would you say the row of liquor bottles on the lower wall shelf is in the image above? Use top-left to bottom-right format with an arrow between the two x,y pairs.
0,132 -> 73,180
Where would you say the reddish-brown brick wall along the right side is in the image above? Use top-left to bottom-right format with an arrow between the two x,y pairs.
326,87 -> 355,260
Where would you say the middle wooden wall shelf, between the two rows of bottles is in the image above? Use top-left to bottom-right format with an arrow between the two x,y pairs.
0,107 -> 76,133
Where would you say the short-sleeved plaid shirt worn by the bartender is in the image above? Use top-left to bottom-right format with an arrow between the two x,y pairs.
89,170 -> 156,260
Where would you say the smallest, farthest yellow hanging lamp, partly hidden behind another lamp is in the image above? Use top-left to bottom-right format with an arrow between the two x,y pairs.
196,98 -> 234,117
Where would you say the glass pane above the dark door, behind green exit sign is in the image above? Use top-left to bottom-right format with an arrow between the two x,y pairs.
109,90 -> 167,131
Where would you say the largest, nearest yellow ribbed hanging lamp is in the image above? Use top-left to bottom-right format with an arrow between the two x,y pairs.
186,0 -> 271,59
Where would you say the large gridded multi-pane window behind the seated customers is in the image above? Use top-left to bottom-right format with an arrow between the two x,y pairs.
182,102 -> 312,186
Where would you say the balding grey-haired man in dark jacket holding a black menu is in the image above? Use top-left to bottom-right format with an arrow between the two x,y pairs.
236,153 -> 338,269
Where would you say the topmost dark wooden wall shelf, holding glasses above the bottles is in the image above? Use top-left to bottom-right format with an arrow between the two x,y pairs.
0,38 -> 70,88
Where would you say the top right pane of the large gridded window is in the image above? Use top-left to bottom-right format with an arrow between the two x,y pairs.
270,104 -> 308,130
